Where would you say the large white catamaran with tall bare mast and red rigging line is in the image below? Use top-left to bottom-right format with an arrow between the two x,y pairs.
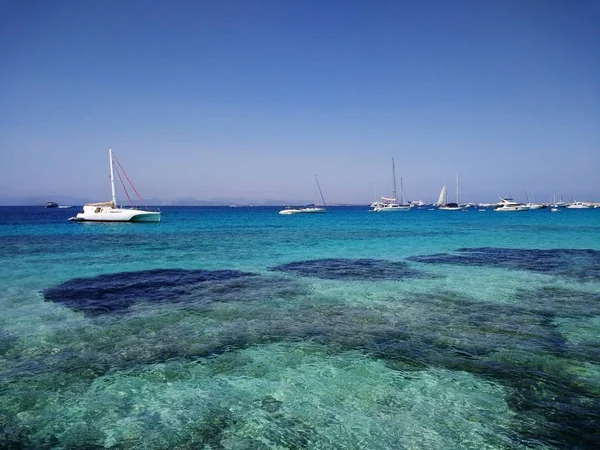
69,148 -> 161,222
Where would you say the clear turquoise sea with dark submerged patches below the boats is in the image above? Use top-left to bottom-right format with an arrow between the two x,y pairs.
0,206 -> 600,450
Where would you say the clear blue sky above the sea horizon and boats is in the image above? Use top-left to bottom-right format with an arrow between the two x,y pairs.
0,0 -> 600,202
